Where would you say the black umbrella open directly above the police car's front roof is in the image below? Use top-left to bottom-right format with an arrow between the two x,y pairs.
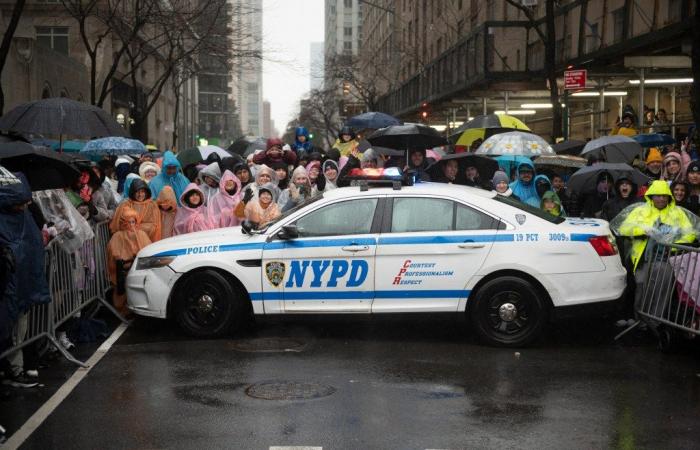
367,123 -> 447,150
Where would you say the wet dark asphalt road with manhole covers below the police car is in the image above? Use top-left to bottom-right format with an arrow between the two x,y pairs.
13,317 -> 700,450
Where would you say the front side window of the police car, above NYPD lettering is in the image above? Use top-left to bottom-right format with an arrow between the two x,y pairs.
296,198 -> 377,237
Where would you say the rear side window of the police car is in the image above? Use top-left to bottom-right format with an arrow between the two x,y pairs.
391,198 -> 500,233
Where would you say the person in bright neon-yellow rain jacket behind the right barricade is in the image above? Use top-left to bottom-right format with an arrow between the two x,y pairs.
610,180 -> 698,312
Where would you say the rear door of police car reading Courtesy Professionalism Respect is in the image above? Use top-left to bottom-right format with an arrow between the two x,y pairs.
372,196 -> 500,312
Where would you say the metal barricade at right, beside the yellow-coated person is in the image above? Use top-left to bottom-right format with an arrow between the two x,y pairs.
624,240 -> 700,349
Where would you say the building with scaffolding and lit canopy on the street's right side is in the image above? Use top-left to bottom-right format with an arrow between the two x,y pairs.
360,0 -> 693,138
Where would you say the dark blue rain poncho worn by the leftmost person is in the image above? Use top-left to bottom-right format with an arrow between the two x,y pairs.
0,173 -> 51,324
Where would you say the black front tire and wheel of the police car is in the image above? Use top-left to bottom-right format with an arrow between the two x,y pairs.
173,270 -> 248,338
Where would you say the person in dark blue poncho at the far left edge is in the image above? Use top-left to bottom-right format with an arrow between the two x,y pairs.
0,174 -> 51,387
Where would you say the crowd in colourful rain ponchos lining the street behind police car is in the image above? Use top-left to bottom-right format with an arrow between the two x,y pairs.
0,116 -> 700,400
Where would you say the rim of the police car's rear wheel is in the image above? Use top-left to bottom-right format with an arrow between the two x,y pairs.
486,291 -> 532,336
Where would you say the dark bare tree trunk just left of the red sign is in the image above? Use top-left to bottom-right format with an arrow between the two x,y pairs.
506,0 -> 562,139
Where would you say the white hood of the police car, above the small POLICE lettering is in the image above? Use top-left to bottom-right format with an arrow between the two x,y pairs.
138,226 -> 265,258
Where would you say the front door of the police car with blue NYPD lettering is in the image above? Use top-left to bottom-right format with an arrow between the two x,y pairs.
263,196 -> 381,313
